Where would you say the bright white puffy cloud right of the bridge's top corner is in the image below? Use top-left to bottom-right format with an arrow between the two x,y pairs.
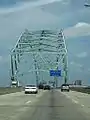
64,22 -> 90,37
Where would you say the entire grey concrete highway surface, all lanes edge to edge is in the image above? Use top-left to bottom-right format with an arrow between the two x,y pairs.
0,90 -> 90,120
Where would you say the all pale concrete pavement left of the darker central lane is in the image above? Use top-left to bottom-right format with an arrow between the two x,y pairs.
0,91 -> 44,120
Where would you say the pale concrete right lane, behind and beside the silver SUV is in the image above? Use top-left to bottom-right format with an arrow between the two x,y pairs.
59,91 -> 90,114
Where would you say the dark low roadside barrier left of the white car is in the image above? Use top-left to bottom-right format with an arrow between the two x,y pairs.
0,87 -> 22,95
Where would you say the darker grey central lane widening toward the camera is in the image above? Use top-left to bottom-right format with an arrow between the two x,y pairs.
17,90 -> 90,120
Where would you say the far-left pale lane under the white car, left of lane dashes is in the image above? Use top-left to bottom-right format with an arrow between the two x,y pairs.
0,90 -> 44,106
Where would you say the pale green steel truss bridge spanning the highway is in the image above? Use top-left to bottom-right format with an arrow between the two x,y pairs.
11,29 -> 68,86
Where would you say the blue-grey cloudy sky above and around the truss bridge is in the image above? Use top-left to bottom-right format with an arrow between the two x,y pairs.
0,0 -> 90,85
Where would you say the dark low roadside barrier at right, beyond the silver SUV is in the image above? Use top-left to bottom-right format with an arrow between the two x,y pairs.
70,87 -> 90,94
